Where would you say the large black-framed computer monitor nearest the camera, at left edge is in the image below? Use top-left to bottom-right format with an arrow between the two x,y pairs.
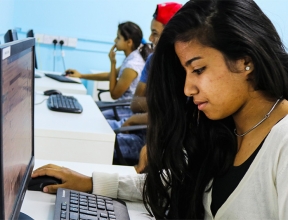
0,38 -> 35,219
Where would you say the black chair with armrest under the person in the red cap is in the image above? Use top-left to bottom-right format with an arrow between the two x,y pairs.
113,125 -> 147,166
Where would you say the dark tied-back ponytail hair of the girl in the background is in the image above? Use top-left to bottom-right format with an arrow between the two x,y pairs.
118,21 -> 153,61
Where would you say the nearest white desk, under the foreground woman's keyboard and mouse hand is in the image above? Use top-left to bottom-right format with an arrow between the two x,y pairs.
21,160 -> 153,220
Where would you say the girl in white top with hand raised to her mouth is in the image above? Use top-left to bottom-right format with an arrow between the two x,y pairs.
66,21 -> 152,119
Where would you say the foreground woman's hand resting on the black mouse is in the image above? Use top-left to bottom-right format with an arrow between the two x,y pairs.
32,164 -> 92,193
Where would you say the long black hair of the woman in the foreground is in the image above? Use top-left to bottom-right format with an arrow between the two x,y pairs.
143,0 -> 288,219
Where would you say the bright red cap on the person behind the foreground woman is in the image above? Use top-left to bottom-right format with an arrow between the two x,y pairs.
154,2 -> 182,25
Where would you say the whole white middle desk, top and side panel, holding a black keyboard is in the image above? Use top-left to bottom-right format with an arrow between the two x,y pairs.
34,93 -> 115,164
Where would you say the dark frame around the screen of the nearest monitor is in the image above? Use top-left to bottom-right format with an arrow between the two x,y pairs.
0,38 -> 35,219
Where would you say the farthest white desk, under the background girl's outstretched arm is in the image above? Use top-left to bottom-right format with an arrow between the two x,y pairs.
34,70 -> 87,95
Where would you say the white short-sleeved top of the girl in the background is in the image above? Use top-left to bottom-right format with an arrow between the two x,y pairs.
118,50 -> 145,100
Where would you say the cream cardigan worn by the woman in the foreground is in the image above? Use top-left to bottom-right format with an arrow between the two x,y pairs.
93,116 -> 288,220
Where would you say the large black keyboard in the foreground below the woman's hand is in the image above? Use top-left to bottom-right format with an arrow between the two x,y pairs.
53,188 -> 130,220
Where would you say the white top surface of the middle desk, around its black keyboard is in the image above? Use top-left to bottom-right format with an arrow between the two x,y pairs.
34,93 -> 115,141
